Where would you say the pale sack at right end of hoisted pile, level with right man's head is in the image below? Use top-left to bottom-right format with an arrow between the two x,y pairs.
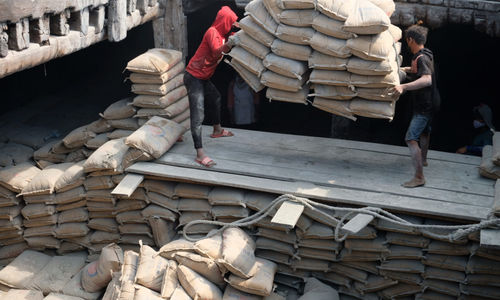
347,31 -> 394,61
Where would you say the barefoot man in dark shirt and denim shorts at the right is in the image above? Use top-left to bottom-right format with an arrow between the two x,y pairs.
393,25 -> 440,188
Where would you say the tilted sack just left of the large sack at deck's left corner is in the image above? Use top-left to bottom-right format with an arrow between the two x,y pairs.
83,138 -> 128,173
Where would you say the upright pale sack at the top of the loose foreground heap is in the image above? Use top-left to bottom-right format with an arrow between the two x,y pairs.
221,228 -> 256,278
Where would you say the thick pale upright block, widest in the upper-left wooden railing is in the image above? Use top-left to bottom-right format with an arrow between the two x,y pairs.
108,0 -> 127,42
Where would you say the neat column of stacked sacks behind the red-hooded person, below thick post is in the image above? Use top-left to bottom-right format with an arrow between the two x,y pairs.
127,48 -> 190,130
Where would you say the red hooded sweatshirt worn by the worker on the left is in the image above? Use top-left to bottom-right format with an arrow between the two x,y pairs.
186,6 -> 238,80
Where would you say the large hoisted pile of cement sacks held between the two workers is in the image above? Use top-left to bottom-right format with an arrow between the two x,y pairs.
229,0 -> 401,120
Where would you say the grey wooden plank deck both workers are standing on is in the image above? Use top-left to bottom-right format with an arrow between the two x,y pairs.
128,127 -> 495,221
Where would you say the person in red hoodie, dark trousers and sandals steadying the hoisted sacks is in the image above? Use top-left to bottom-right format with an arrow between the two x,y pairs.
184,6 -> 238,167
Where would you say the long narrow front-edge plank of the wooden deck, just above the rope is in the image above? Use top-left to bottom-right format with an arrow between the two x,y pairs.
127,162 -> 490,221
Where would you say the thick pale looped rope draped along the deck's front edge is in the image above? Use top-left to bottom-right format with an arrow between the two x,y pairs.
183,194 -> 500,242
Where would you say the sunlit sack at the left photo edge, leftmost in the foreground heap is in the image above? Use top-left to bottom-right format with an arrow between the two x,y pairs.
0,247 -> 51,288
